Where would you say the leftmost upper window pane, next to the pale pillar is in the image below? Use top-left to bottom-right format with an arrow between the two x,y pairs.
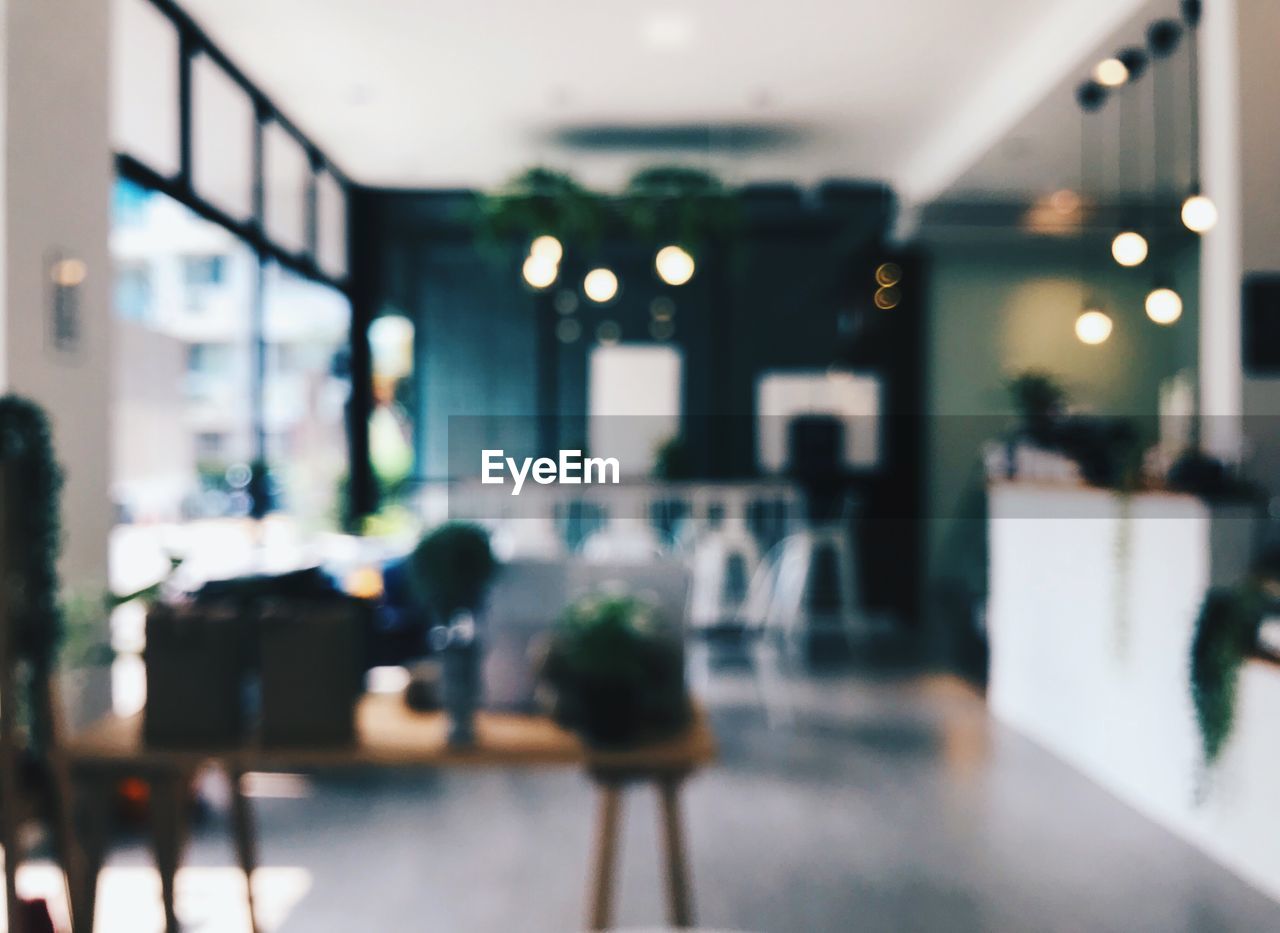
111,0 -> 180,177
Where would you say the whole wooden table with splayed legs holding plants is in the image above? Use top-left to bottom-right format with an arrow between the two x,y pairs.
67,694 -> 716,933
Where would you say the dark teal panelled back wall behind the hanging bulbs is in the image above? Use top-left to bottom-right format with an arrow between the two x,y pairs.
353,183 -> 923,619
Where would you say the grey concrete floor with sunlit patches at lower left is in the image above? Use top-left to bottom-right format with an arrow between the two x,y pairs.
100,674 -> 1280,933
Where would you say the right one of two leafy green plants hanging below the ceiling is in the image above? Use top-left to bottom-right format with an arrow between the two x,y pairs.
621,165 -> 739,246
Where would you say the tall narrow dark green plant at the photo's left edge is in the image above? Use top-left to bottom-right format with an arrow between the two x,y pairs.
0,395 -> 63,673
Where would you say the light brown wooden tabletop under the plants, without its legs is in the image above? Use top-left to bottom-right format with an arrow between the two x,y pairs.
65,694 -> 716,777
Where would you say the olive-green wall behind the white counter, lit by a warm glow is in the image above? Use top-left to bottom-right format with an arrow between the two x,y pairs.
924,241 -> 1198,651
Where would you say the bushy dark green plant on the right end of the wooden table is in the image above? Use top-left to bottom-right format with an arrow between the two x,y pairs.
541,595 -> 690,747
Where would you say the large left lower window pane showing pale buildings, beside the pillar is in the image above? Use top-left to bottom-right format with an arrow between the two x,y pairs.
111,180 -> 257,532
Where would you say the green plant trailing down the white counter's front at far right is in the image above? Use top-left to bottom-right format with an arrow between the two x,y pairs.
1190,584 -> 1265,769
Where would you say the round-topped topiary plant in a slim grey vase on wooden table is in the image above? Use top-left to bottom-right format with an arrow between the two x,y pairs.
410,522 -> 498,745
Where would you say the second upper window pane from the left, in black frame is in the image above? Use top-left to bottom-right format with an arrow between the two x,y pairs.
191,55 -> 255,220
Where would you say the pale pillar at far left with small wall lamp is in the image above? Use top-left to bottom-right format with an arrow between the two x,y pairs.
0,0 -> 113,593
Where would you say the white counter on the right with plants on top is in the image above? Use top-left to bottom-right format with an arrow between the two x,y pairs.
988,482 -> 1280,900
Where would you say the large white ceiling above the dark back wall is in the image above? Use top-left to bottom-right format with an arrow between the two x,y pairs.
180,0 -> 1143,200
